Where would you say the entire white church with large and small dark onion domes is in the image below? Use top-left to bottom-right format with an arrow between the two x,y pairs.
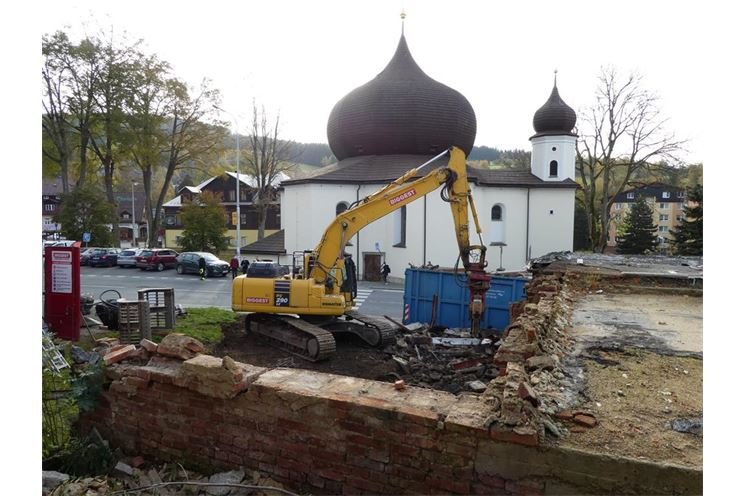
253,23 -> 578,280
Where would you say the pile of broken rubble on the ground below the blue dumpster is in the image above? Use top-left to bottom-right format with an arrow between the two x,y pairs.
381,324 -> 500,394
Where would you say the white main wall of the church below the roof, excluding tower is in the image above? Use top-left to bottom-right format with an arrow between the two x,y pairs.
282,180 -> 574,280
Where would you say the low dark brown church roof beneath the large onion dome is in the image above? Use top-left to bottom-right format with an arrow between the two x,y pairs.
282,155 -> 578,188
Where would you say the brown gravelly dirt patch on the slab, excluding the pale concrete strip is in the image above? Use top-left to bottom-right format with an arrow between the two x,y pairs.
563,348 -> 703,467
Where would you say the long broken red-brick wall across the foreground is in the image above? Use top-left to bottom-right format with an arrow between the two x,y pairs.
80,355 -> 700,494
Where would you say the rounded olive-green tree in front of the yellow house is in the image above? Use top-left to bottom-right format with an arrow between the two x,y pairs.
181,192 -> 228,253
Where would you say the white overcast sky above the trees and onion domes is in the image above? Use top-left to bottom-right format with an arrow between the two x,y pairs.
39,0 -> 724,165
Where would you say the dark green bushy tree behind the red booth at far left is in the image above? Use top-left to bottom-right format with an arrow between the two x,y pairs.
55,185 -> 116,246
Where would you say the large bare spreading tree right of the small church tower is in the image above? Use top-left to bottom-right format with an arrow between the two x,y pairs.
577,68 -> 684,252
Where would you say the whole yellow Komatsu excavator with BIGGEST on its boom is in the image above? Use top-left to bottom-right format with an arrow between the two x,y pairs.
232,147 -> 490,362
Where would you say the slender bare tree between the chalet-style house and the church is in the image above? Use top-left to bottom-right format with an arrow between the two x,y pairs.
246,100 -> 299,239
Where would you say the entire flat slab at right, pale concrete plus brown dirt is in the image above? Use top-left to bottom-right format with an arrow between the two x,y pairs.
566,289 -> 703,467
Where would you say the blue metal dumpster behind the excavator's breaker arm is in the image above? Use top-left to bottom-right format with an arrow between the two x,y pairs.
403,268 -> 528,331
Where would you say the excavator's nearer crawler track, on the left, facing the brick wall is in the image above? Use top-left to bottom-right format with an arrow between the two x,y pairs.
246,313 -> 336,362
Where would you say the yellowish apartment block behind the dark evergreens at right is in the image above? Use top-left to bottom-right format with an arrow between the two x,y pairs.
608,183 -> 686,251
